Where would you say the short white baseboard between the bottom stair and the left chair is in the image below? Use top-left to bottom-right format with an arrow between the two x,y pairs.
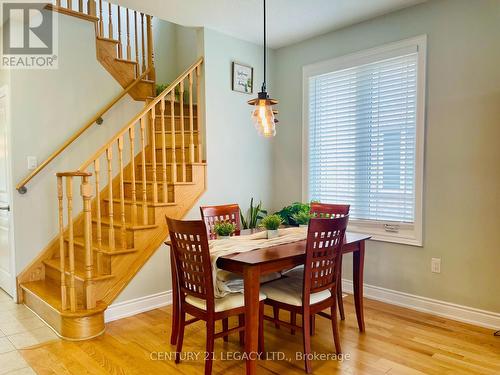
104,290 -> 172,323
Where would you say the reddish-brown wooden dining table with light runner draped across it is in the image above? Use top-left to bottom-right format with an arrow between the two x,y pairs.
165,230 -> 371,375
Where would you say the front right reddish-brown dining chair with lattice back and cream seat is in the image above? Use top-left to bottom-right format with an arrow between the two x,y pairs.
261,215 -> 349,374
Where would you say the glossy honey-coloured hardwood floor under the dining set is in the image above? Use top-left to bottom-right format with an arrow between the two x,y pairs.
17,296 -> 500,375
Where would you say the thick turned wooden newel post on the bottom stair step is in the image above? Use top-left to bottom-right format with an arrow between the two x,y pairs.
80,176 -> 96,309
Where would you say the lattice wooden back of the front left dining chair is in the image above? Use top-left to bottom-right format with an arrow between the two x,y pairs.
167,218 -> 214,311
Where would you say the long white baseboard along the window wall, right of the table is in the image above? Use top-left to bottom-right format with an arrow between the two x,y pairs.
342,279 -> 500,329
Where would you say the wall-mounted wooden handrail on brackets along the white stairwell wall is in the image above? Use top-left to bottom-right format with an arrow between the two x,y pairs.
16,68 -> 150,194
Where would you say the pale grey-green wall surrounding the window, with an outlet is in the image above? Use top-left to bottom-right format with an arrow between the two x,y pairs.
273,0 -> 500,312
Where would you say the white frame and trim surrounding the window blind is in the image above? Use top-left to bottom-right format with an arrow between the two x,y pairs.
302,35 -> 427,246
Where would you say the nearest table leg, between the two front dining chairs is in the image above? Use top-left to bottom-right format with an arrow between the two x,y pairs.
243,266 -> 260,375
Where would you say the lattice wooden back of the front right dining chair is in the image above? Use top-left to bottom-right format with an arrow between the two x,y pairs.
303,215 -> 349,304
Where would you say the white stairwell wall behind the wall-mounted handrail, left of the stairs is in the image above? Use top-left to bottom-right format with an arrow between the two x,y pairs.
11,13 -> 143,273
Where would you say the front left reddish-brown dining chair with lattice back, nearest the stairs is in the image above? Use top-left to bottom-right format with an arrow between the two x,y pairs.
167,217 -> 266,375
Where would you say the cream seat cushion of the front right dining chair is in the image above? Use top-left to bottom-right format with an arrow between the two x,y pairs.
261,277 -> 331,306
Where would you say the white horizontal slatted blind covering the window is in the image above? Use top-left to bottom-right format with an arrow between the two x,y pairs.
309,53 -> 417,223
